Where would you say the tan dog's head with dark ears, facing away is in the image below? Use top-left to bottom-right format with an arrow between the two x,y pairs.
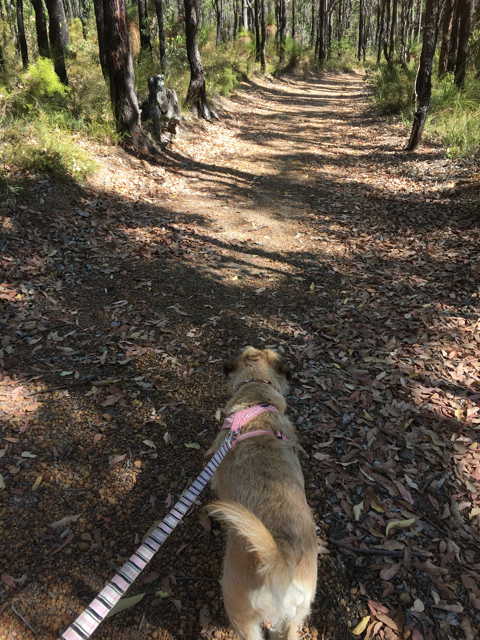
224,347 -> 291,395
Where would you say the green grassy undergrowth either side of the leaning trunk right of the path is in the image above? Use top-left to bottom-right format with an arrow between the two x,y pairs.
371,63 -> 480,158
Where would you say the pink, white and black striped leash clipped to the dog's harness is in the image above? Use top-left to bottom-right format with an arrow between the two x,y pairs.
60,433 -> 235,640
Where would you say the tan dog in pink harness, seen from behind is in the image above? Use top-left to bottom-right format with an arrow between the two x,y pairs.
207,347 -> 318,640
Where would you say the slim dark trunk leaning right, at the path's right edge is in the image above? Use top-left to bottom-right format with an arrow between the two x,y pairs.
406,0 -> 437,151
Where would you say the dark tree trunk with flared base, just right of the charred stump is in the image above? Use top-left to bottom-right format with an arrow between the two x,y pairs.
183,0 -> 217,120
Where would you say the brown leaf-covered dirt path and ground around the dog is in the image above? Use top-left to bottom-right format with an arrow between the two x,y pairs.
0,75 -> 480,640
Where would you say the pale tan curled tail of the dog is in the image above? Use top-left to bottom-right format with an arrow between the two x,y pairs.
207,501 -> 290,575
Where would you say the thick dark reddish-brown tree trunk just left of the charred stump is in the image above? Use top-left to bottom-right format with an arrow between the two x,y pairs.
97,0 -> 145,146
